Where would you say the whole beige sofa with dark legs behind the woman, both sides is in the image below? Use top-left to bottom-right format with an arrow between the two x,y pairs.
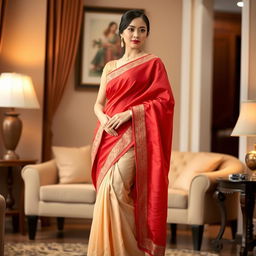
22,149 -> 244,249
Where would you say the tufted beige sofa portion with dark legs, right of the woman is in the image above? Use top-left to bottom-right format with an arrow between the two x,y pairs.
167,152 -> 245,250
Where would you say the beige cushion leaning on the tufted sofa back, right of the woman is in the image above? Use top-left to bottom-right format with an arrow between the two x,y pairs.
172,153 -> 223,191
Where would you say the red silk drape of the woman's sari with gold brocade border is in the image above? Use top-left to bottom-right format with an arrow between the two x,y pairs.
92,54 -> 174,256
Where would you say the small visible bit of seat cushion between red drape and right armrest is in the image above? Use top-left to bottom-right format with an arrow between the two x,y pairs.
168,188 -> 188,209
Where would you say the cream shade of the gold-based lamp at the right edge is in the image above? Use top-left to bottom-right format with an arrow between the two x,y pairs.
231,100 -> 256,136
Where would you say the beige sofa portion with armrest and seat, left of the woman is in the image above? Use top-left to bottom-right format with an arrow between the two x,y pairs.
22,148 -> 96,240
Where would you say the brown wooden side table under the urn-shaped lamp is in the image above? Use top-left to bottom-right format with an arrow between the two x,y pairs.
0,159 -> 37,235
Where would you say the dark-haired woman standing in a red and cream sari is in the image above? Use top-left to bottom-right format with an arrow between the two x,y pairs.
88,10 -> 174,256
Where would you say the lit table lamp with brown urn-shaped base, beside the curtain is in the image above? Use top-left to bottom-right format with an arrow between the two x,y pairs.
0,73 -> 40,160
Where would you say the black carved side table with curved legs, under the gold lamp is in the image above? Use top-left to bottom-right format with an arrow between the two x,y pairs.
214,179 -> 256,256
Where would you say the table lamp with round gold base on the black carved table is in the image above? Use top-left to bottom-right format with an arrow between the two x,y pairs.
231,100 -> 256,179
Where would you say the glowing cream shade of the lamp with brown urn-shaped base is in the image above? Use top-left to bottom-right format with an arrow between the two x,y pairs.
0,73 -> 40,108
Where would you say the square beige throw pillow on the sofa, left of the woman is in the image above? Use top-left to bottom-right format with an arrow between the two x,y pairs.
52,145 -> 92,184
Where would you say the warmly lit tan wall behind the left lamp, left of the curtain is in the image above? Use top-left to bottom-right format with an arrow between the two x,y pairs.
0,0 -> 46,202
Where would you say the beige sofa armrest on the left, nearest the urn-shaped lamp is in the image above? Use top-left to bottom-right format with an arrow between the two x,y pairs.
21,160 -> 58,215
